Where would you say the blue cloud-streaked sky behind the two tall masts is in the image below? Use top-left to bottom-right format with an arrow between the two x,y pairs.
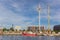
0,0 -> 60,29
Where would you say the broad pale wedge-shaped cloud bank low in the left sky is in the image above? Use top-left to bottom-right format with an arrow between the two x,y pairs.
0,4 -> 37,27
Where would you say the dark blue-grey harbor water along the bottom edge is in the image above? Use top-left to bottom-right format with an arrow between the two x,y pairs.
0,35 -> 60,40
